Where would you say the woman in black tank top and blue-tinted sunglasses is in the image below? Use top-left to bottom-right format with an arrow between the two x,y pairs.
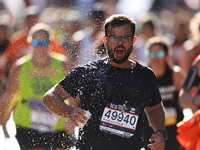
144,36 -> 185,150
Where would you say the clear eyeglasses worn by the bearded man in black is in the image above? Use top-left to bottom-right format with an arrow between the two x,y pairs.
108,35 -> 133,43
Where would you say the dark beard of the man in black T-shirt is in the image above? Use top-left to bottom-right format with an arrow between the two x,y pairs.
106,45 -> 133,64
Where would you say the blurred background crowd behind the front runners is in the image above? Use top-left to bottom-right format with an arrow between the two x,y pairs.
0,0 -> 200,149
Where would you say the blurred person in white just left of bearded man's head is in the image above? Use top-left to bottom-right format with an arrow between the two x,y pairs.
75,3 -> 106,65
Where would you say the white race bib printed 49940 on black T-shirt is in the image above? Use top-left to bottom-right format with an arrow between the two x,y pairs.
99,103 -> 139,138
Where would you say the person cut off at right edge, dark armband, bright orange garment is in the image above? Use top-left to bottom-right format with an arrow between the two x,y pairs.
177,55 -> 200,150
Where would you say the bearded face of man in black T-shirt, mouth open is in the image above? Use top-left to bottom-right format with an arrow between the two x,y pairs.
106,24 -> 133,63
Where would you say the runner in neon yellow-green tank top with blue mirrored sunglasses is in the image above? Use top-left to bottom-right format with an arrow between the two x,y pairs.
0,23 -> 75,150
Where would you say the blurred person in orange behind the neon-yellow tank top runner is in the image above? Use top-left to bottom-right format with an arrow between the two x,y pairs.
0,6 -> 67,78
